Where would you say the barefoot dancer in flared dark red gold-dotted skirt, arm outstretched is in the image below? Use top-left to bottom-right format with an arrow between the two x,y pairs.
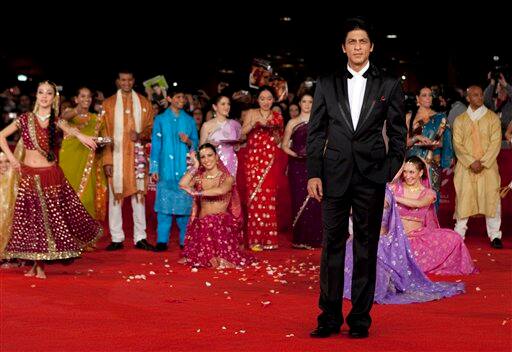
0,81 -> 102,279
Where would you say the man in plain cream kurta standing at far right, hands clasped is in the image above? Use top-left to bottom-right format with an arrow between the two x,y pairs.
453,86 -> 503,248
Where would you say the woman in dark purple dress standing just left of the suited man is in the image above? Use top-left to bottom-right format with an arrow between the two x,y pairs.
283,94 -> 322,249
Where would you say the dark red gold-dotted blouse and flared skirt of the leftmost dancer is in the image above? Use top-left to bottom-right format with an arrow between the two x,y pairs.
3,113 -> 103,260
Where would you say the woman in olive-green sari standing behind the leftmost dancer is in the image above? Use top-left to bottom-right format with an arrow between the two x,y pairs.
59,87 -> 107,220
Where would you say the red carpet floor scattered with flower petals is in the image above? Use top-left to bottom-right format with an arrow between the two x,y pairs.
0,230 -> 512,351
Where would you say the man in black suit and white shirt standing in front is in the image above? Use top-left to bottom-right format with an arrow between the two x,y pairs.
307,18 -> 407,338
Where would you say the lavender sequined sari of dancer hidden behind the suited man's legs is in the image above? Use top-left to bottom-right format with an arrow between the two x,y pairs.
343,187 -> 464,304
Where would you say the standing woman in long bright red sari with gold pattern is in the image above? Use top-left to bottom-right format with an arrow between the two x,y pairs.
242,87 -> 283,251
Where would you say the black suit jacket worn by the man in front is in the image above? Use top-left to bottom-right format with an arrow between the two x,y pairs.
307,65 -> 407,197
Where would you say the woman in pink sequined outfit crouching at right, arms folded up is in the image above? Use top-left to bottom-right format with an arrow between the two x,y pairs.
390,156 -> 477,275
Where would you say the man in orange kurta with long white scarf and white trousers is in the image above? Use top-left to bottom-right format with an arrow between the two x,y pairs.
103,72 -> 153,250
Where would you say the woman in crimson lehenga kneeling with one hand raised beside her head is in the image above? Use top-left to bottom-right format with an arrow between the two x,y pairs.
180,143 -> 252,268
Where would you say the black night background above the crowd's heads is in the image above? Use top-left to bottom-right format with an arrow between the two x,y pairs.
0,5 -> 512,95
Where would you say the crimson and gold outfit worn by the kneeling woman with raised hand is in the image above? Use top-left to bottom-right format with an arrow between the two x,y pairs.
183,160 -> 253,268
